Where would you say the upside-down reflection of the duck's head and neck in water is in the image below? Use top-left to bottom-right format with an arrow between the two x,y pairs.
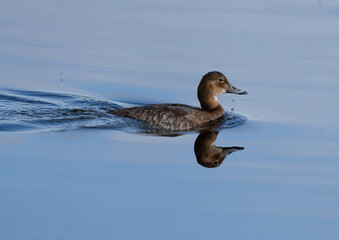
194,131 -> 244,168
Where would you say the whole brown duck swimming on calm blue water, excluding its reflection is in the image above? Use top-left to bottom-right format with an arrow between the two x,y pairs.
108,71 -> 247,131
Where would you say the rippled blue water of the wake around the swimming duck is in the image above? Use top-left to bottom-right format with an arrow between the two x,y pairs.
0,90 -> 246,136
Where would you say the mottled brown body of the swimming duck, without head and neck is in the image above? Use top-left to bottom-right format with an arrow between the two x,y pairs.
109,104 -> 223,130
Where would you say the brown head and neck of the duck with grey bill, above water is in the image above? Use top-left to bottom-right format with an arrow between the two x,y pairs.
198,71 -> 247,110
